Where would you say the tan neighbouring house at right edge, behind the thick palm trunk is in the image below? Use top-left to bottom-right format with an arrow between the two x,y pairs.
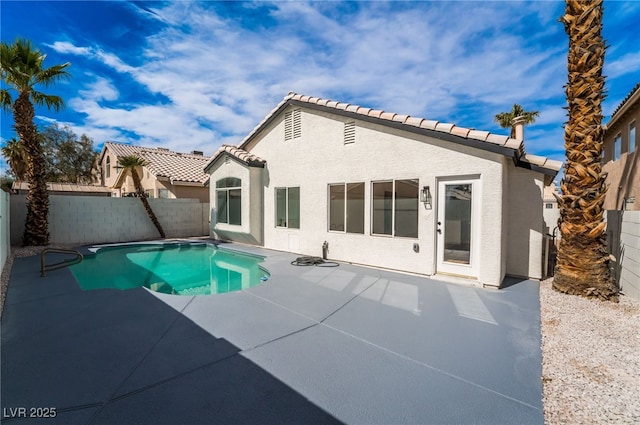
602,83 -> 640,210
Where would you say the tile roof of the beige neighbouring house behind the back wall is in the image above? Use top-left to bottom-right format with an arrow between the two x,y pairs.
101,142 -> 209,184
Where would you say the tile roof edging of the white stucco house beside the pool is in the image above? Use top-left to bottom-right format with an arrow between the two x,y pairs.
205,92 -> 562,183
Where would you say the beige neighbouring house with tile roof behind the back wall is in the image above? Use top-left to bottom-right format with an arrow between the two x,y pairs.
98,142 -> 209,202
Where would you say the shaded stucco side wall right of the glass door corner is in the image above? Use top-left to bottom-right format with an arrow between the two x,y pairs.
506,164 -> 544,279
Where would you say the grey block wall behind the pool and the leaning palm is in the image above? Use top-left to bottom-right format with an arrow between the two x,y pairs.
11,195 -> 209,245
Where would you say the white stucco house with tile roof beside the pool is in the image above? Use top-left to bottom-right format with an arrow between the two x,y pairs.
205,93 -> 561,286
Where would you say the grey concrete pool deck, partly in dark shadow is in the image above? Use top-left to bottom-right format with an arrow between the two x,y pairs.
0,240 -> 543,425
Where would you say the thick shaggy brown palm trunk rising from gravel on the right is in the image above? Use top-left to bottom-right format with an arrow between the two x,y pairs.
553,0 -> 618,301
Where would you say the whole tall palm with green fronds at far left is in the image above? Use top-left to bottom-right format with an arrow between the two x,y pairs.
0,39 -> 69,245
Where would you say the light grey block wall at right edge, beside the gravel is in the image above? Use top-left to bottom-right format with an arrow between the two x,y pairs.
619,211 -> 640,299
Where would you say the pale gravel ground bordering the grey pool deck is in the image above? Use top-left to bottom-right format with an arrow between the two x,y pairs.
0,245 -> 640,425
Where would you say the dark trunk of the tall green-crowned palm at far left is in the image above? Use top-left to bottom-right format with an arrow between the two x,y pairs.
13,92 -> 49,246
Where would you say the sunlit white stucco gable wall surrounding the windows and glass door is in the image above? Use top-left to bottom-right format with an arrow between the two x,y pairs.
248,110 -> 505,285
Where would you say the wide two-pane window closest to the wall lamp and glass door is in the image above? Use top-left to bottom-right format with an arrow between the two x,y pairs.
371,179 -> 418,238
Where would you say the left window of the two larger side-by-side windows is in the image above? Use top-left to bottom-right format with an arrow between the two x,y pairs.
329,183 -> 364,233
